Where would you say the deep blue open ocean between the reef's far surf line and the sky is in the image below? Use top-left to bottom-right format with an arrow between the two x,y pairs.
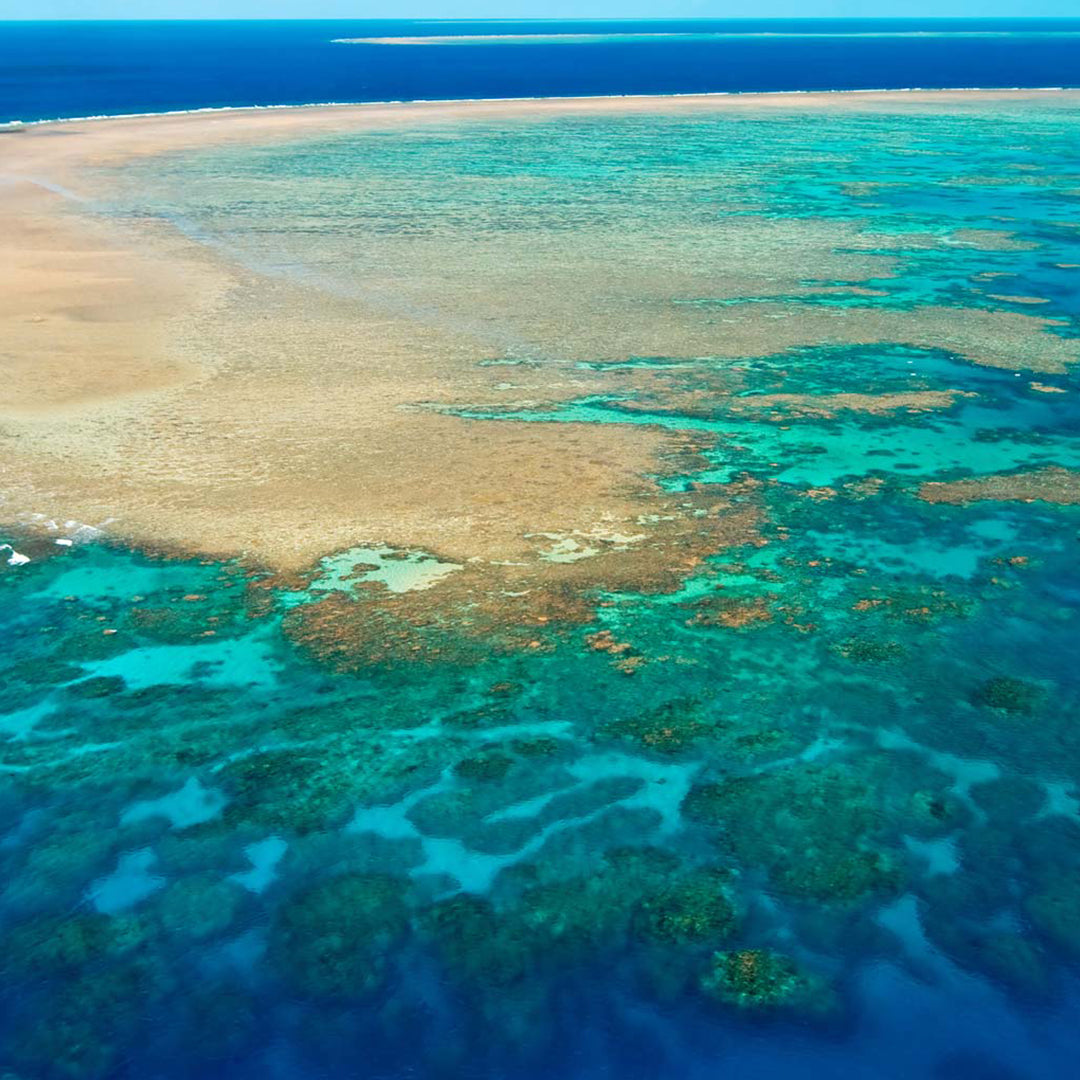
0,19 -> 1080,121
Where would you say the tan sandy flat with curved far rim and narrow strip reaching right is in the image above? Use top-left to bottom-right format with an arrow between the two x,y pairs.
0,93 -> 1071,613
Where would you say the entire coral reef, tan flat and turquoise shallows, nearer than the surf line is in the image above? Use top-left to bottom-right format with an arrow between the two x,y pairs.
0,92 -> 1080,1080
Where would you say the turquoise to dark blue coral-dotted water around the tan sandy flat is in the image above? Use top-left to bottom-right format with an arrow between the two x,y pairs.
0,97 -> 1080,1080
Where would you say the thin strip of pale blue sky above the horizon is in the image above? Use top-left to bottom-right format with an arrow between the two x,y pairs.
0,0 -> 1080,18
